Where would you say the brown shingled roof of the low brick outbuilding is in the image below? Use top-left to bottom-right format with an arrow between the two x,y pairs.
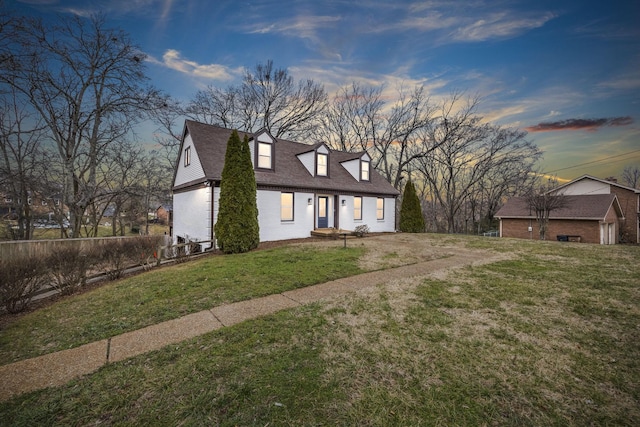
495,194 -> 622,220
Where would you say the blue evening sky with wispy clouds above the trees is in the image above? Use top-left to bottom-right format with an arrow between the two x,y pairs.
10,0 -> 640,180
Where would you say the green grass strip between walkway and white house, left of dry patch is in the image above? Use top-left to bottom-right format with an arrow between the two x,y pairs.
0,246 -> 364,365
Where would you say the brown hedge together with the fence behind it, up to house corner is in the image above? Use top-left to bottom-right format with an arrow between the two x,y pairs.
0,236 -> 203,313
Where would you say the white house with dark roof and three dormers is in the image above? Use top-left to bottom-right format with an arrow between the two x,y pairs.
172,120 -> 399,248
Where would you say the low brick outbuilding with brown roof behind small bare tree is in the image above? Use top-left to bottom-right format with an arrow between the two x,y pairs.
495,194 -> 624,245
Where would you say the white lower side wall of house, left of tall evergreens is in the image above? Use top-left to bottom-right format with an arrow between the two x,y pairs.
173,187 -> 212,247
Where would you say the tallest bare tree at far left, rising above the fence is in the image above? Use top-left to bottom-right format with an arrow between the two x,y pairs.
0,16 -> 158,237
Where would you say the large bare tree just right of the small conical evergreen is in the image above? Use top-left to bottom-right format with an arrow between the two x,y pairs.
418,94 -> 541,233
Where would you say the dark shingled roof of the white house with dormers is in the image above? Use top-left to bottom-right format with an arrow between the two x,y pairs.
174,120 -> 400,197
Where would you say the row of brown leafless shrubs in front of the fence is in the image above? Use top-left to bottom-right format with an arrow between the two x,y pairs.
0,236 -> 163,313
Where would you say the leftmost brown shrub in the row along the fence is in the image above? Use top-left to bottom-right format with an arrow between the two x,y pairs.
0,257 -> 48,313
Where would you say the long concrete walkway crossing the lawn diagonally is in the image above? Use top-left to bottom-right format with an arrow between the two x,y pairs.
0,250 -> 498,401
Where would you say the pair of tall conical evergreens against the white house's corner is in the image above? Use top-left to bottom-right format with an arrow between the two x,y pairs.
214,130 -> 260,254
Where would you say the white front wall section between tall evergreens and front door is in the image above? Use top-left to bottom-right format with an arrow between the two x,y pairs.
258,190 -> 315,242
